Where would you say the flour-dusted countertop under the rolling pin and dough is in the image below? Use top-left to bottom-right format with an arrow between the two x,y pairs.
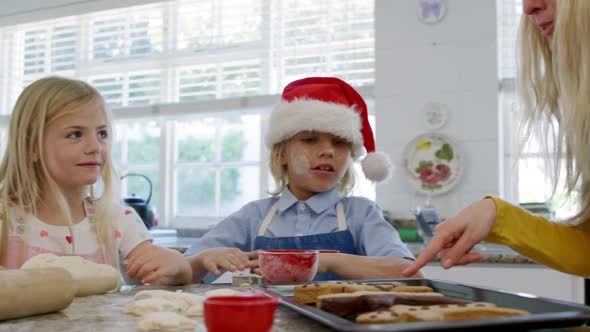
0,285 -> 590,332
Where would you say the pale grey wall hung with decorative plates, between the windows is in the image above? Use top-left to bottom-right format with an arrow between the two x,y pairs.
375,0 -> 500,217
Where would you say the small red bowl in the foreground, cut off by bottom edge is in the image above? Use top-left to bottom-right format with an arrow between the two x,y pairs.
203,295 -> 279,332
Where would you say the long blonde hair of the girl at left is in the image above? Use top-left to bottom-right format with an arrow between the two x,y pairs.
0,76 -> 119,268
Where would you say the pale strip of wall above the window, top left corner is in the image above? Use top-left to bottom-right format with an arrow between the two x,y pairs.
0,0 -> 162,26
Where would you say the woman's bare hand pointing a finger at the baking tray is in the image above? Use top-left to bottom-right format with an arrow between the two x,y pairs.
402,199 -> 496,277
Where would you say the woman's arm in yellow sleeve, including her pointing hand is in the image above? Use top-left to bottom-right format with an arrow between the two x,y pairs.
404,197 -> 590,277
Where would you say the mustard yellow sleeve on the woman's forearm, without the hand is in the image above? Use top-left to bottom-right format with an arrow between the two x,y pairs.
486,197 -> 590,277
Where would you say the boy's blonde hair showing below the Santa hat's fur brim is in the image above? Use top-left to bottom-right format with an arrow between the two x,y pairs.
269,139 -> 356,196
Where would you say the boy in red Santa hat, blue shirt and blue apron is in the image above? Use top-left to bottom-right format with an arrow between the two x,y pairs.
187,77 -> 421,281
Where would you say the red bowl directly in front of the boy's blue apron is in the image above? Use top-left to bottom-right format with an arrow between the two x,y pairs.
258,250 -> 319,284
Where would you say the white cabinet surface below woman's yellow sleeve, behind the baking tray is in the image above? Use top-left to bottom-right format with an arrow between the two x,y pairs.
422,263 -> 584,304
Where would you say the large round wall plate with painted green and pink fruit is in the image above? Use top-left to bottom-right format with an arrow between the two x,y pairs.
402,133 -> 462,195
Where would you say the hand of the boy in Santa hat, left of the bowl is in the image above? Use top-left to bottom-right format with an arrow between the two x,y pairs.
198,248 -> 258,276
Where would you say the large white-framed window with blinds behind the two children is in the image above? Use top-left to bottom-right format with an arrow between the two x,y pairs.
0,0 -> 375,228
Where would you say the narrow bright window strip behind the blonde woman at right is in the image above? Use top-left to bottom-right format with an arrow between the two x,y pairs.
497,0 -> 577,219
